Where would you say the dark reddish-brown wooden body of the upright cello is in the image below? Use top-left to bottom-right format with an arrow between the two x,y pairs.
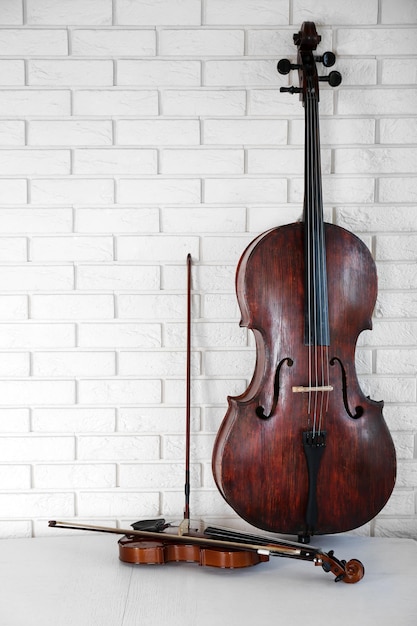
213,218 -> 395,536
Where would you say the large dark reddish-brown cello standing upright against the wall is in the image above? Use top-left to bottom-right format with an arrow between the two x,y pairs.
212,22 -> 396,543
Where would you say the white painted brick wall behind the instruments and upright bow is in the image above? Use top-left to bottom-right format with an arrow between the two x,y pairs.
0,0 -> 417,537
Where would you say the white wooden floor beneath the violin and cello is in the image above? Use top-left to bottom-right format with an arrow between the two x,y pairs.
0,533 -> 417,626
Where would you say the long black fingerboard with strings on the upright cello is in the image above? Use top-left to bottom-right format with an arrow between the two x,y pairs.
303,88 -> 330,346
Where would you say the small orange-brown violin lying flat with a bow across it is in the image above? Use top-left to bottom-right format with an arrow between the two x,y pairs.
49,520 -> 365,583
